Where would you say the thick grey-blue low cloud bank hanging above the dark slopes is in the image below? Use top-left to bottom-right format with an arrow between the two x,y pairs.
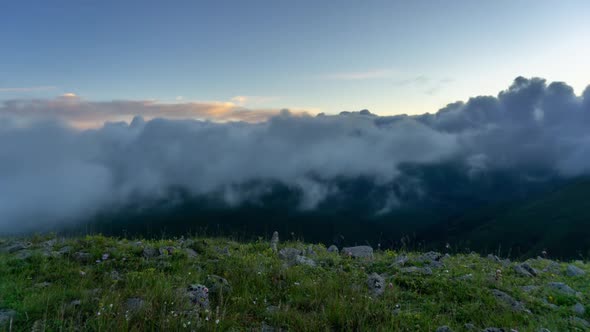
0,77 -> 590,232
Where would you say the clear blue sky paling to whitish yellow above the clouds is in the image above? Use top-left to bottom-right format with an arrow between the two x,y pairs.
0,0 -> 590,114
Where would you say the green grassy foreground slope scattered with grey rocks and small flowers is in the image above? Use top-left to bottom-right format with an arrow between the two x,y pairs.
0,234 -> 590,332
